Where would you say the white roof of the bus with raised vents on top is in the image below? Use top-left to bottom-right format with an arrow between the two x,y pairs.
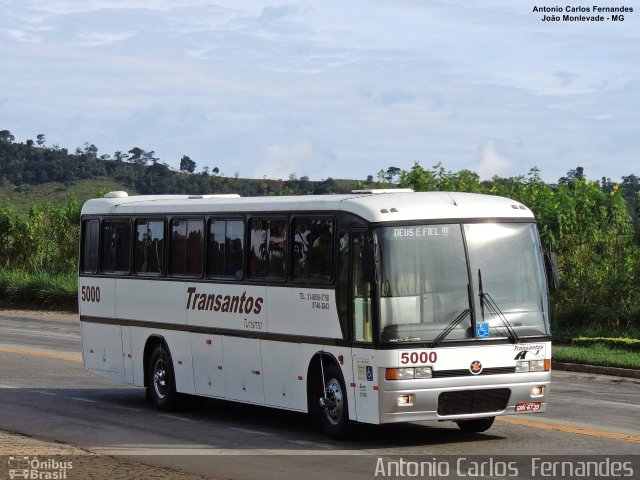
82,190 -> 533,222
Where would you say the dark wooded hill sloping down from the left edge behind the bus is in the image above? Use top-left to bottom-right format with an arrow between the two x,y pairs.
0,130 -> 357,196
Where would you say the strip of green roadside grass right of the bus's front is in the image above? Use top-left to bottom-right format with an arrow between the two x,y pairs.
552,343 -> 640,369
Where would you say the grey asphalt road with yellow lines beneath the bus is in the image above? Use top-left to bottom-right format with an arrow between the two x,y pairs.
0,311 -> 640,479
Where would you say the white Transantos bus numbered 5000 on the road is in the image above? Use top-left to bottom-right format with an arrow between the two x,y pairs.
78,190 -> 556,437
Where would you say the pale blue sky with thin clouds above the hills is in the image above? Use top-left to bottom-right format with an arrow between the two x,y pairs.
0,0 -> 640,183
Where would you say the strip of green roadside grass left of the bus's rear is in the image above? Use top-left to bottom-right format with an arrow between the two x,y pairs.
0,270 -> 78,307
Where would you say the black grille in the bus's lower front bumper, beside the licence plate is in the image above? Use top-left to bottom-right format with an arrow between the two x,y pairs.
438,388 -> 511,416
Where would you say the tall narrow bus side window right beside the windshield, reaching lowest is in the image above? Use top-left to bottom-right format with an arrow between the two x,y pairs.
351,232 -> 373,342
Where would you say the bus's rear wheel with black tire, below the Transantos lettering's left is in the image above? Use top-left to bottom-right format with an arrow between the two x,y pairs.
147,344 -> 178,412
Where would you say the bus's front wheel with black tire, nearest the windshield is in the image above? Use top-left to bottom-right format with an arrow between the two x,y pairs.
318,364 -> 351,440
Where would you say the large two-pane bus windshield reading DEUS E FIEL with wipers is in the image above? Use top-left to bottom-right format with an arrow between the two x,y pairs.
376,223 -> 549,343
